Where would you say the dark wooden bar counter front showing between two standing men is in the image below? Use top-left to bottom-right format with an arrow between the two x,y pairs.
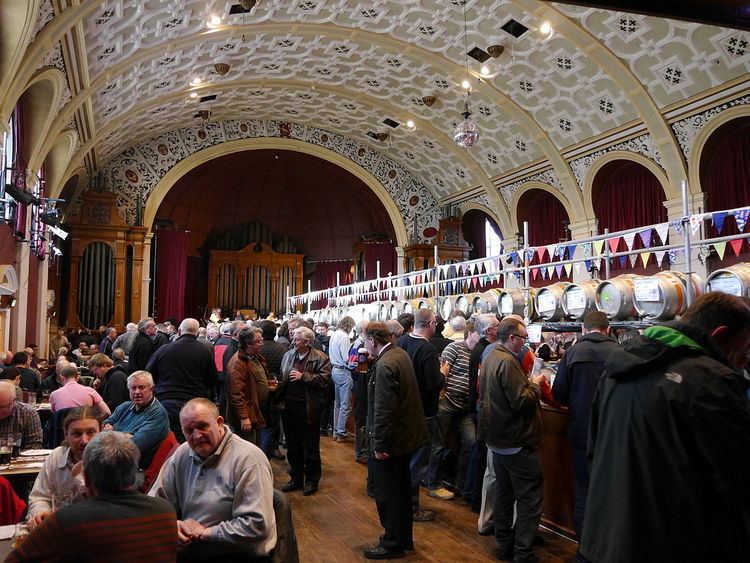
539,405 -> 575,538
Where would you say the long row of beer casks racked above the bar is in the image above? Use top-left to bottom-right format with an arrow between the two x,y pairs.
312,263 -> 750,325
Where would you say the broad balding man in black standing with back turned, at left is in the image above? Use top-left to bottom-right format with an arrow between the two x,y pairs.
146,319 -> 218,442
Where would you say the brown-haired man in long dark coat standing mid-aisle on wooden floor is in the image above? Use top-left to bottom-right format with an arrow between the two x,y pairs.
364,323 -> 429,559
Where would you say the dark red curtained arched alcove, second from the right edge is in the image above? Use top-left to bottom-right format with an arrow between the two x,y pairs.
591,160 -> 667,274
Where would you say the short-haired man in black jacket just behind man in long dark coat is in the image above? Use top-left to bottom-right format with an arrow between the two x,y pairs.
397,309 -> 444,522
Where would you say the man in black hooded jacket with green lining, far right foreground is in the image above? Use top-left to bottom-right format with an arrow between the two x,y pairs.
580,292 -> 750,563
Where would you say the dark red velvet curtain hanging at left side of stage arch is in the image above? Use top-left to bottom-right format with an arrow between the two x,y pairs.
156,229 -> 189,322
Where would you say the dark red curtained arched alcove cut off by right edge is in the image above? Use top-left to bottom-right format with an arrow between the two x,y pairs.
700,117 -> 750,270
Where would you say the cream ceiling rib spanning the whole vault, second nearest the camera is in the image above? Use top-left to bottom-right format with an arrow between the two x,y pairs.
42,17 -> 575,215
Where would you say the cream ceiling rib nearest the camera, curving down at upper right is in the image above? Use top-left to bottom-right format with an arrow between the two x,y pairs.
512,0 -> 687,199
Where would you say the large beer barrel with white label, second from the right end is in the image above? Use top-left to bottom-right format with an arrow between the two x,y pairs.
633,271 -> 703,321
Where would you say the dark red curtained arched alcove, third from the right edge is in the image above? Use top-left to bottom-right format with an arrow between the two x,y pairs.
516,188 -> 570,287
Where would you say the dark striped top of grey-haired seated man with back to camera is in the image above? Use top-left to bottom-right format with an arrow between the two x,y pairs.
6,491 -> 177,563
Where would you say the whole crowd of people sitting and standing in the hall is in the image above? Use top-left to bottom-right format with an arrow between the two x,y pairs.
0,293 -> 750,563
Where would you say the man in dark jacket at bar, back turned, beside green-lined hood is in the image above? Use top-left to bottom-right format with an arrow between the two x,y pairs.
552,311 -> 617,538
